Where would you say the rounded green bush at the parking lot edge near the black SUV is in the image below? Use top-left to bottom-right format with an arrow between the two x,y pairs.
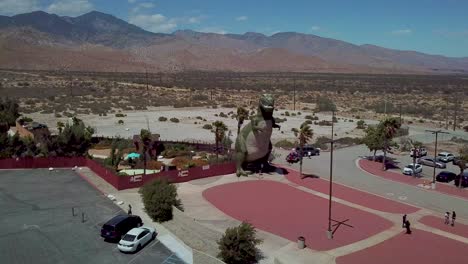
139,179 -> 182,223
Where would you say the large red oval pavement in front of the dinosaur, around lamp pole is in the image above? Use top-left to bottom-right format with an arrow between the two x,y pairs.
203,180 -> 392,250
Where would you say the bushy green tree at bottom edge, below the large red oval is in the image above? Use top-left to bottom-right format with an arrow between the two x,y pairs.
218,222 -> 263,264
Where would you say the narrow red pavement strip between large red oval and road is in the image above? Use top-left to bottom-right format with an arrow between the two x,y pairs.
286,168 -> 419,214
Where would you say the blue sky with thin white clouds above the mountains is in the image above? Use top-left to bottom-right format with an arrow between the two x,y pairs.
0,0 -> 468,57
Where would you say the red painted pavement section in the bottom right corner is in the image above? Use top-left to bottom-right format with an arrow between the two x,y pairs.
336,229 -> 468,264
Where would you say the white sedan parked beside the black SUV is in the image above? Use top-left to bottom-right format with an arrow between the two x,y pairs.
117,226 -> 156,252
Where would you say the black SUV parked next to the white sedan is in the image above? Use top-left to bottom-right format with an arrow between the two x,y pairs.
101,215 -> 143,240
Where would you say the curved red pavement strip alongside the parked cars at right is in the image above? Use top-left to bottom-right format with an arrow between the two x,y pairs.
359,159 -> 468,199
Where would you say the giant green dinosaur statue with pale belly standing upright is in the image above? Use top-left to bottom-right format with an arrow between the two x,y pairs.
236,94 -> 281,176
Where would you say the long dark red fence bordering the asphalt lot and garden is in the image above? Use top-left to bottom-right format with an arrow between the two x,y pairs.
0,157 -> 236,190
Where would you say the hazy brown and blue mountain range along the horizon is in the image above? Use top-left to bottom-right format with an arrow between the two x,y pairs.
0,11 -> 468,74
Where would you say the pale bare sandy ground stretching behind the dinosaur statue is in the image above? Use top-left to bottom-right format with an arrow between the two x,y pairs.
28,107 -> 376,142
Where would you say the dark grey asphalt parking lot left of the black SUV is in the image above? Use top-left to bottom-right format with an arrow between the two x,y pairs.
0,169 -> 184,264
